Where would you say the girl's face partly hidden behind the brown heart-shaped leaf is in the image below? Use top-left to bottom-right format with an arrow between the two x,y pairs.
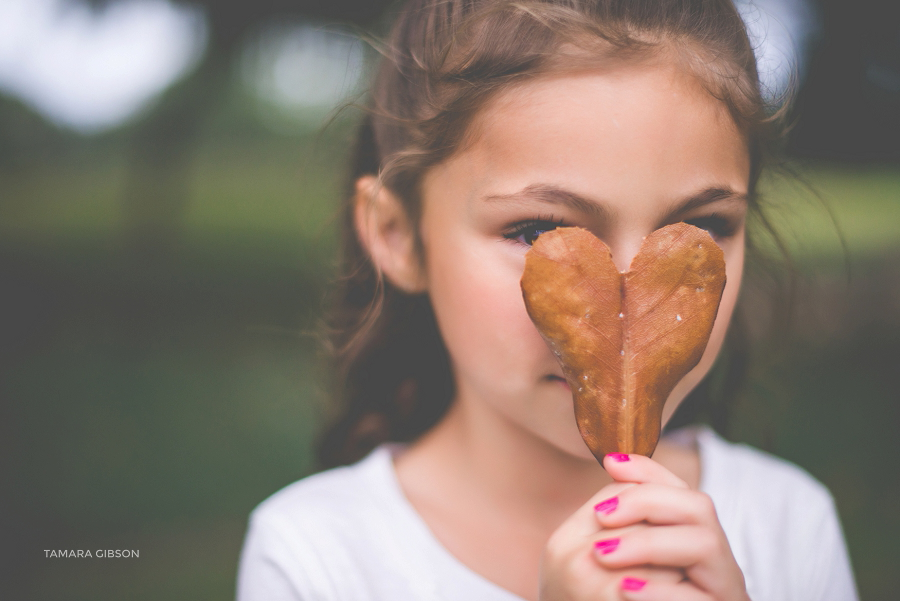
420,59 -> 750,461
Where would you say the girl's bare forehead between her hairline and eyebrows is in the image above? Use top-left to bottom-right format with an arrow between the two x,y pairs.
454,65 -> 749,185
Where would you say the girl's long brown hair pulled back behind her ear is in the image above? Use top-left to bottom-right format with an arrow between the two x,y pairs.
319,0 -> 783,467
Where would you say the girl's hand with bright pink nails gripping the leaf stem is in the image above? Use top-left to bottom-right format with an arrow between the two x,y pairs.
540,454 -> 749,601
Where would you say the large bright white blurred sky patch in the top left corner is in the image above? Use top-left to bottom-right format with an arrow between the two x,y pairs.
0,0 -> 206,132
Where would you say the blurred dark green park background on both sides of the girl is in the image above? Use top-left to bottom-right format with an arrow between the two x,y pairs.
0,2 -> 900,601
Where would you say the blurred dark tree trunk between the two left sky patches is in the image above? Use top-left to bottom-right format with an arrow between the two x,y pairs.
92,0 -> 389,258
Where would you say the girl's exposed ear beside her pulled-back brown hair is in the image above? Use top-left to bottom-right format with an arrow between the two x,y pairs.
353,175 -> 426,294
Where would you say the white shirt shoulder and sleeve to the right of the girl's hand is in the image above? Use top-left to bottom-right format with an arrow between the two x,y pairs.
697,430 -> 859,601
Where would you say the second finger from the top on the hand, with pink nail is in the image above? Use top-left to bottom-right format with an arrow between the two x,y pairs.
594,484 -> 719,528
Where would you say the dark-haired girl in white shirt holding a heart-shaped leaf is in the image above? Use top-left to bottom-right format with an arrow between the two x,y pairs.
238,0 -> 856,601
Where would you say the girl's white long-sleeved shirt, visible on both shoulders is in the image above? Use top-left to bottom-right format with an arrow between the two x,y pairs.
237,428 -> 857,601
